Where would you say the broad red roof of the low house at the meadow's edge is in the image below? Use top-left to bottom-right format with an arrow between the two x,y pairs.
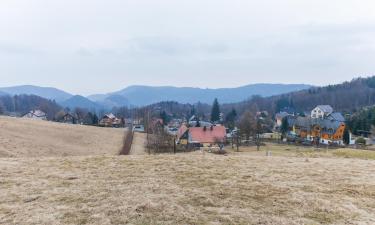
189,126 -> 227,143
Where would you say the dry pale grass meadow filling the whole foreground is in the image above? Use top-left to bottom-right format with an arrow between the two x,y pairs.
0,118 -> 375,225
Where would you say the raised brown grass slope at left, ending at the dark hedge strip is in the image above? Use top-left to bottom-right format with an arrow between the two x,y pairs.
0,116 -> 124,157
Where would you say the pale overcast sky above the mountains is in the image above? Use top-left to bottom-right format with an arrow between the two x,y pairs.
0,0 -> 375,95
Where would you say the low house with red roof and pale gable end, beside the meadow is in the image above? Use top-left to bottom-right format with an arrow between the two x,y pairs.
177,125 -> 226,147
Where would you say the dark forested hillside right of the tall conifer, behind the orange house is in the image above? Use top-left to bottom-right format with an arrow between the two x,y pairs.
223,76 -> 375,116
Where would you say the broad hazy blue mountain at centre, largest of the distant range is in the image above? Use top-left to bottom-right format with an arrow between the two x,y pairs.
88,84 -> 311,106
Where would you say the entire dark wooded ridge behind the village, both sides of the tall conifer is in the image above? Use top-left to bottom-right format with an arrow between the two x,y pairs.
133,77 -> 375,120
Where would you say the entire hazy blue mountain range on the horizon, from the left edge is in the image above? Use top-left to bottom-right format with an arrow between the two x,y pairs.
0,84 -> 312,110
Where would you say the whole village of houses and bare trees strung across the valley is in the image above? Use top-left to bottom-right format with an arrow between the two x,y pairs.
19,102 -> 370,148
